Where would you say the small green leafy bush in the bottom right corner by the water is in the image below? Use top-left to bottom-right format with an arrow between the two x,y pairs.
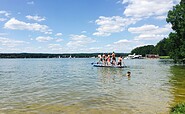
170,103 -> 185,114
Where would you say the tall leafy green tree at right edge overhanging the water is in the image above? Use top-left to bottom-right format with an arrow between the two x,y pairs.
166,0 -> 185,62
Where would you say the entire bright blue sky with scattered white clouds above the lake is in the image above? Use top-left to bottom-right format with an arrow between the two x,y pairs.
0,0 -> 179,53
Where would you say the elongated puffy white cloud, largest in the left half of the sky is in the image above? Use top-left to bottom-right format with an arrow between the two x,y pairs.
4,18 -> 52,33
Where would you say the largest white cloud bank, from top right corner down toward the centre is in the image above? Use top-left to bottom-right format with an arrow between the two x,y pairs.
93,0 -> 179,36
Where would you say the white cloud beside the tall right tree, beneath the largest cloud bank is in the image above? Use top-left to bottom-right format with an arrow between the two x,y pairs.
128,24 -> 171,40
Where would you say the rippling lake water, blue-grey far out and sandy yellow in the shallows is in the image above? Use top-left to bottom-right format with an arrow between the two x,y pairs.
0,58 -> 185,114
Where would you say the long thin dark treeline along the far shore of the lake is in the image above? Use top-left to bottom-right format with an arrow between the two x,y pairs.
0,53 -> 128,58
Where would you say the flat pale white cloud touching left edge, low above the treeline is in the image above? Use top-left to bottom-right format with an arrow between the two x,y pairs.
0,37 -> 28,47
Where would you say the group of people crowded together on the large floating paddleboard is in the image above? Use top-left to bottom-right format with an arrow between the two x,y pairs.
98,52 -> 123,66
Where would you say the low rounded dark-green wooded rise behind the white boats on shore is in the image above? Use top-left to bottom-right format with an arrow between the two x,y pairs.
131,45 -> 154,56
